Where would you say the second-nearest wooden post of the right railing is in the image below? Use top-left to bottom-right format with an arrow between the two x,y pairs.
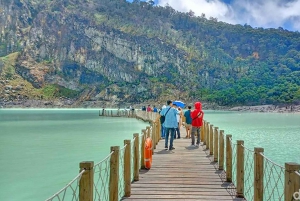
254,147 -> 264,201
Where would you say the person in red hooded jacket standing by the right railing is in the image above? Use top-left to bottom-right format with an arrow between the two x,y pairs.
191,102 -> 204,146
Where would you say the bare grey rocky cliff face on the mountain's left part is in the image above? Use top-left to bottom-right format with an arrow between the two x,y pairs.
0,0 -> 189,107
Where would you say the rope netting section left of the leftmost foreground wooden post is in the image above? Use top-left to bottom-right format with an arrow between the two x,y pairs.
46,170 -> 85,201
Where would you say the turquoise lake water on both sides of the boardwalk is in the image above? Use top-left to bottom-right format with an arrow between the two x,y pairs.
0,109 -> 300,201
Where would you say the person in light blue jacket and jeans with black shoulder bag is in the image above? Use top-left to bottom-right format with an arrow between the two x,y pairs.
160,100 -> 178,150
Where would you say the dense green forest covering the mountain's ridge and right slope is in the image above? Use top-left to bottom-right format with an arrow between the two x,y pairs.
0,0 -> 300,106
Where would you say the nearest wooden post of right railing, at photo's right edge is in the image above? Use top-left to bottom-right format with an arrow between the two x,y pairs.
284,163 -> 300,201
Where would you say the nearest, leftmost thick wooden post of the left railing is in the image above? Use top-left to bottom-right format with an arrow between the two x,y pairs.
79,161 -> 94,201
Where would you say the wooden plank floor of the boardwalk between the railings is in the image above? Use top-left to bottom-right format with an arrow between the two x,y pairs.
122,129 -> 243,201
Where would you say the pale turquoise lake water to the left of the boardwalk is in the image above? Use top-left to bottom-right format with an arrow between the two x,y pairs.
0,109 -> 148,201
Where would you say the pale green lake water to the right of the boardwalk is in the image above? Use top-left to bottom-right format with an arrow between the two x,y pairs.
205,111 -> 300,166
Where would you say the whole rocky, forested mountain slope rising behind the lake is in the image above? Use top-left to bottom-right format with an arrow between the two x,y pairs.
0,0 -> 300,105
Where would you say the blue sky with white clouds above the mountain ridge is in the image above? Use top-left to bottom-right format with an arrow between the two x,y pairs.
127,0 -> 300,31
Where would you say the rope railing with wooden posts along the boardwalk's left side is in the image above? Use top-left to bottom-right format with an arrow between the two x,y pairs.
46,110 -> 160,201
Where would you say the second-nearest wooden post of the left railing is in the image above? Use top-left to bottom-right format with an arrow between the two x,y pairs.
109,146 -> 120,201
